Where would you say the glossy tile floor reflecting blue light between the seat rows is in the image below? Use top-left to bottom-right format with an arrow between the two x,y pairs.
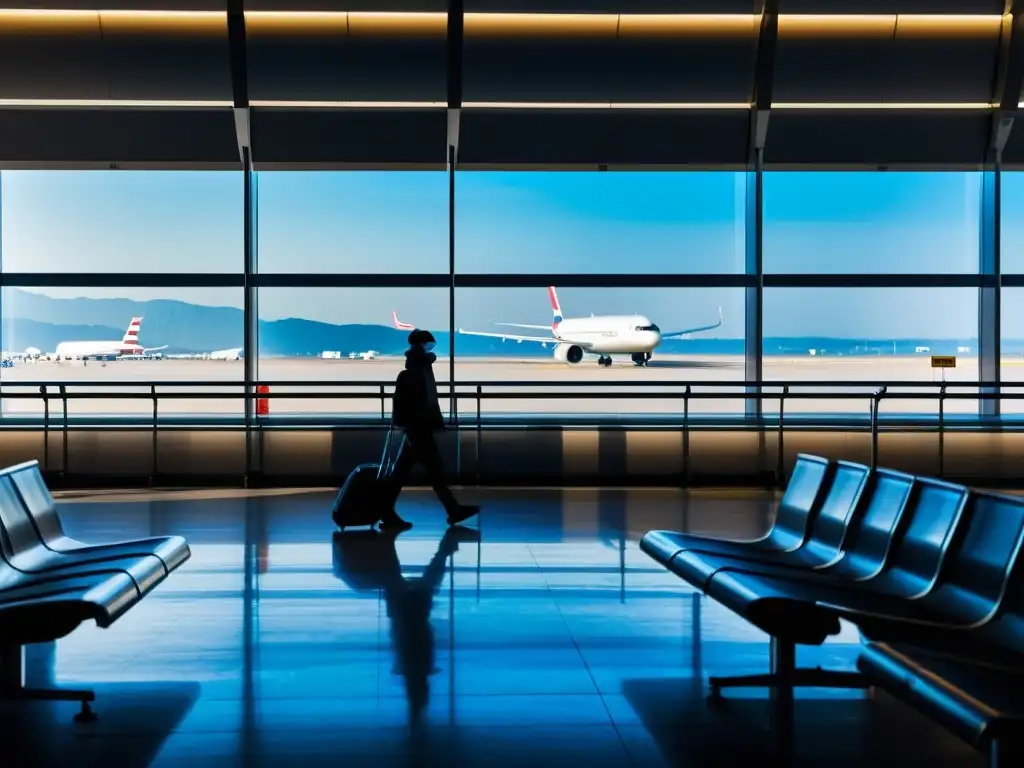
0,489 -> 984,768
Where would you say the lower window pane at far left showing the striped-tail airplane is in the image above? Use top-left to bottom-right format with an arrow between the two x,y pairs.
0,288 -> 245,416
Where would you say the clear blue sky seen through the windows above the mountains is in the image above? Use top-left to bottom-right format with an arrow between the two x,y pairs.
0,171 -> 1024,338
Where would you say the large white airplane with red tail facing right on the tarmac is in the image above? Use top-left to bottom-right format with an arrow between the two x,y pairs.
452,286 -> 722,366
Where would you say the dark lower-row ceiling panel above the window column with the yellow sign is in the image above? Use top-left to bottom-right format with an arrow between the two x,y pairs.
765,110 -> 991,167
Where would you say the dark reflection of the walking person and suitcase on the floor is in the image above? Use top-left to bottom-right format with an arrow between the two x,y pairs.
334,526 -> 479,727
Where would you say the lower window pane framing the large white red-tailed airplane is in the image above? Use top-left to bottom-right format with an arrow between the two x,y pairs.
455,288 -> 743,417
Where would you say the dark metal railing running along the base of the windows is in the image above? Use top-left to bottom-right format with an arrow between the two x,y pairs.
0,381 -> 1024,481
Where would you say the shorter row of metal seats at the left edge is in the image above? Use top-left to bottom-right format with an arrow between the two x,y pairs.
0,461 -> 190,722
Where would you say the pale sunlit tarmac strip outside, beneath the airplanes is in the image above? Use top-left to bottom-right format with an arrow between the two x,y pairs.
0,355 -> 1024,417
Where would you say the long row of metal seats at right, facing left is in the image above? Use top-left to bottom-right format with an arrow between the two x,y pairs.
640,455 -> 1024,766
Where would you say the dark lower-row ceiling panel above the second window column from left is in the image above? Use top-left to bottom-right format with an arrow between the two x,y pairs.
252,109 -> 447,168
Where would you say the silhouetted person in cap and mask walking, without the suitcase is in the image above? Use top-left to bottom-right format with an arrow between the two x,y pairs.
381,329 -> 480,530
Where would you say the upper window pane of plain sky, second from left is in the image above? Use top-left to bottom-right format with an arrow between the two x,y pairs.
257,171 -> 449,274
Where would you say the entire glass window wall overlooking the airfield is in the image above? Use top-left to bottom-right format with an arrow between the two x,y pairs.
0,166 -> 1024,419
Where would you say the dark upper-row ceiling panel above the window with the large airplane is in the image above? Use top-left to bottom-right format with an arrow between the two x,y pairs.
463,36 -> 757,102
